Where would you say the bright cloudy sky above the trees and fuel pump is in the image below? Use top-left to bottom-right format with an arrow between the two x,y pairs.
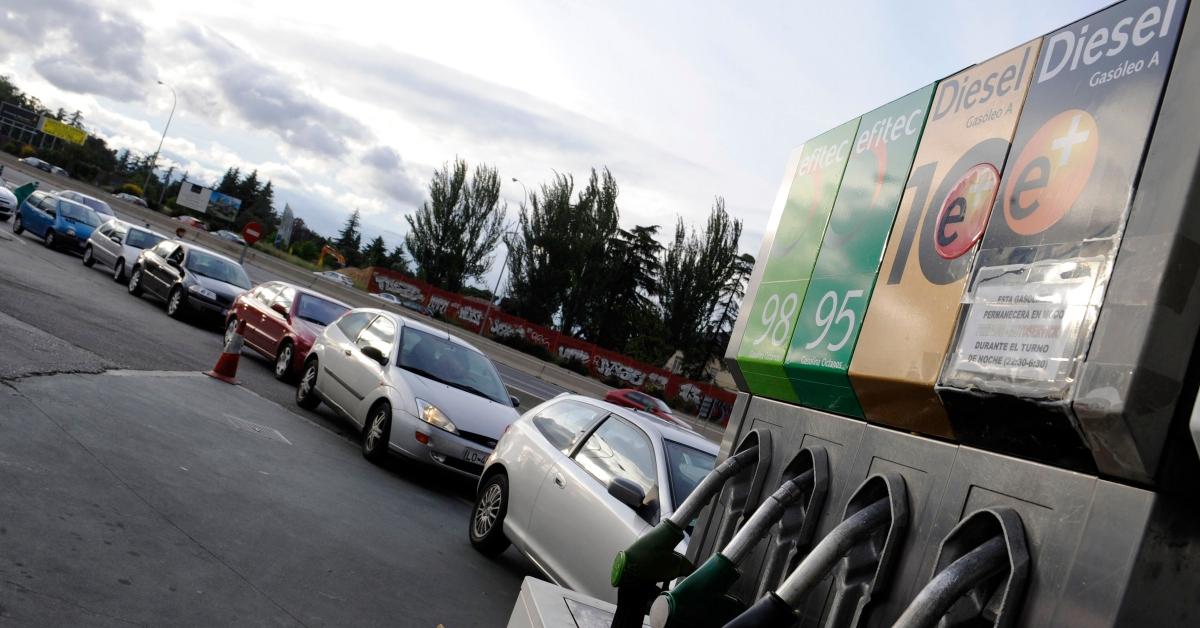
0,0 -> 1110,290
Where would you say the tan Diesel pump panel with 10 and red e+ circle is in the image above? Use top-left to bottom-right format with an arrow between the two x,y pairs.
850,40 -> 1040,437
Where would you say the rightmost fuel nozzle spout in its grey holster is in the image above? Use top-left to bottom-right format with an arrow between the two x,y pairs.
895,508 -> 1030,628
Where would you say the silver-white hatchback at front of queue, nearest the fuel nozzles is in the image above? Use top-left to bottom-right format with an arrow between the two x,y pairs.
468,395 -> 718,602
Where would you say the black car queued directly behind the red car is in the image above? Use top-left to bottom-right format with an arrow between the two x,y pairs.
128,240 -> 251,321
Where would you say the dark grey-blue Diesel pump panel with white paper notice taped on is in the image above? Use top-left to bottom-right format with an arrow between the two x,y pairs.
938,0 -> 1187,461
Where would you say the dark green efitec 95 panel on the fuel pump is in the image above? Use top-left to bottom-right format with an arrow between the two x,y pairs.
784,85 -> 935,417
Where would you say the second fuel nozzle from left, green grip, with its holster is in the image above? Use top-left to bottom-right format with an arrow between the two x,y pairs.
650,447 -> 829,628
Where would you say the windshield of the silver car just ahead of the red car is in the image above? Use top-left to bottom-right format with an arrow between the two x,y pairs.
396,327 -> 512,406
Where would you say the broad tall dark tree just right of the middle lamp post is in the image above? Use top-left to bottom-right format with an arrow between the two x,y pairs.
505,168 -> 619,334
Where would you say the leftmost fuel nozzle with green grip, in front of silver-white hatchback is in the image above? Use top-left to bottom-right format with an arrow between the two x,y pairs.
612,444 -> 769,628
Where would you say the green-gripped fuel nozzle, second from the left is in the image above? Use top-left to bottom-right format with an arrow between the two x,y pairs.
650,456 -> 826,628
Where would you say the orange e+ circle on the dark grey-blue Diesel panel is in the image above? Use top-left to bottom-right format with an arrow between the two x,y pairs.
1004,109 -> 1100,235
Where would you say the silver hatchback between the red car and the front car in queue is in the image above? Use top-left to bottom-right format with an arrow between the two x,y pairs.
296,309 -> 518,477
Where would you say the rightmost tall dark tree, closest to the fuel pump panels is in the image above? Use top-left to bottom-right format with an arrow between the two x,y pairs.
659,197 -> 742,378
